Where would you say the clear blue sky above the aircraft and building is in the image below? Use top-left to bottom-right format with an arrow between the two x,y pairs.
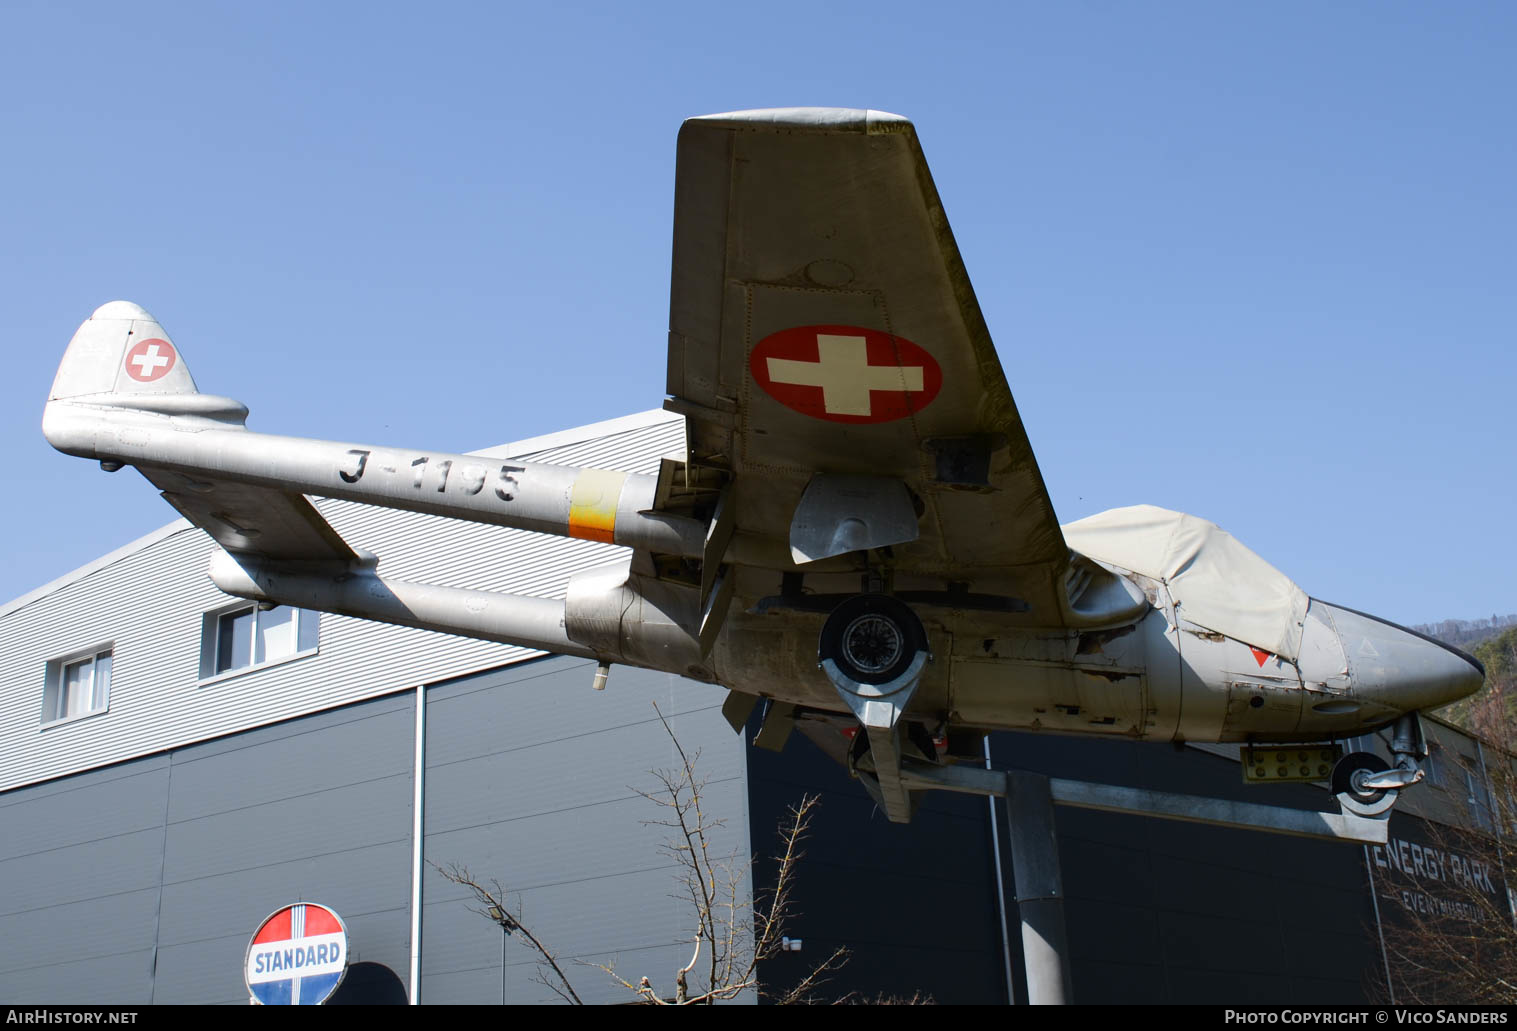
0,0 -> 1517,623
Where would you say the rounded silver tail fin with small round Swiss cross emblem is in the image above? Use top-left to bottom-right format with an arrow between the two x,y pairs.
47,300 -> 199,400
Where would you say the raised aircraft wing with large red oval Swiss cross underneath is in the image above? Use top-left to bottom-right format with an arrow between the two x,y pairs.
666,109 -> 1068,623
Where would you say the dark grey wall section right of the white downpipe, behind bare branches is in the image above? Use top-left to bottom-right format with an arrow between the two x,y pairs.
422,658 -> 751,1004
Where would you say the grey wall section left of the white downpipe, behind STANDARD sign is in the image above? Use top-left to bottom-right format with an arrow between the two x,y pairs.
0,694 -> 413,1004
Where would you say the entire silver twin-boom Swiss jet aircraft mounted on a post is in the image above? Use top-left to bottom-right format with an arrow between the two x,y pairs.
42,108 -> 1484,822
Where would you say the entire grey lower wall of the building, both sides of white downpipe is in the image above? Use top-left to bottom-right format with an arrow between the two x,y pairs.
0,657 -> 748,1004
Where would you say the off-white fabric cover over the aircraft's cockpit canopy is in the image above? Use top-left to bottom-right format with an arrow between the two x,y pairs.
1063,505 -> 1311,661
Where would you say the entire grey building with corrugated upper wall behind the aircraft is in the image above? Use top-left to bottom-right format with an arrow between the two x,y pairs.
0,412 -> 1505,1004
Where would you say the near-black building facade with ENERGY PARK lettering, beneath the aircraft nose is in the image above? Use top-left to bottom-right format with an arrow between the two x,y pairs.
748,734 -> 1382,1004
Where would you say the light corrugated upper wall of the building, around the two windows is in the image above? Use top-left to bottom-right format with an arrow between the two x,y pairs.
0,412 -> 683,790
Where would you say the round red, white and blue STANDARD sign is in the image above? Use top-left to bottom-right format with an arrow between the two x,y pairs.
243,902 -> 347,1005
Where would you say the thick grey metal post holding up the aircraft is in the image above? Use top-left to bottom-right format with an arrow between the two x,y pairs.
1006,772 -> 1071,1005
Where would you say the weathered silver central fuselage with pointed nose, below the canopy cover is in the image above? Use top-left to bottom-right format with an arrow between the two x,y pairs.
710,576 -> 1484,743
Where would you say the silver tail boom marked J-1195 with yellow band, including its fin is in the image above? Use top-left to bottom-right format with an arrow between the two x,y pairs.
42,302 -> 705,558
